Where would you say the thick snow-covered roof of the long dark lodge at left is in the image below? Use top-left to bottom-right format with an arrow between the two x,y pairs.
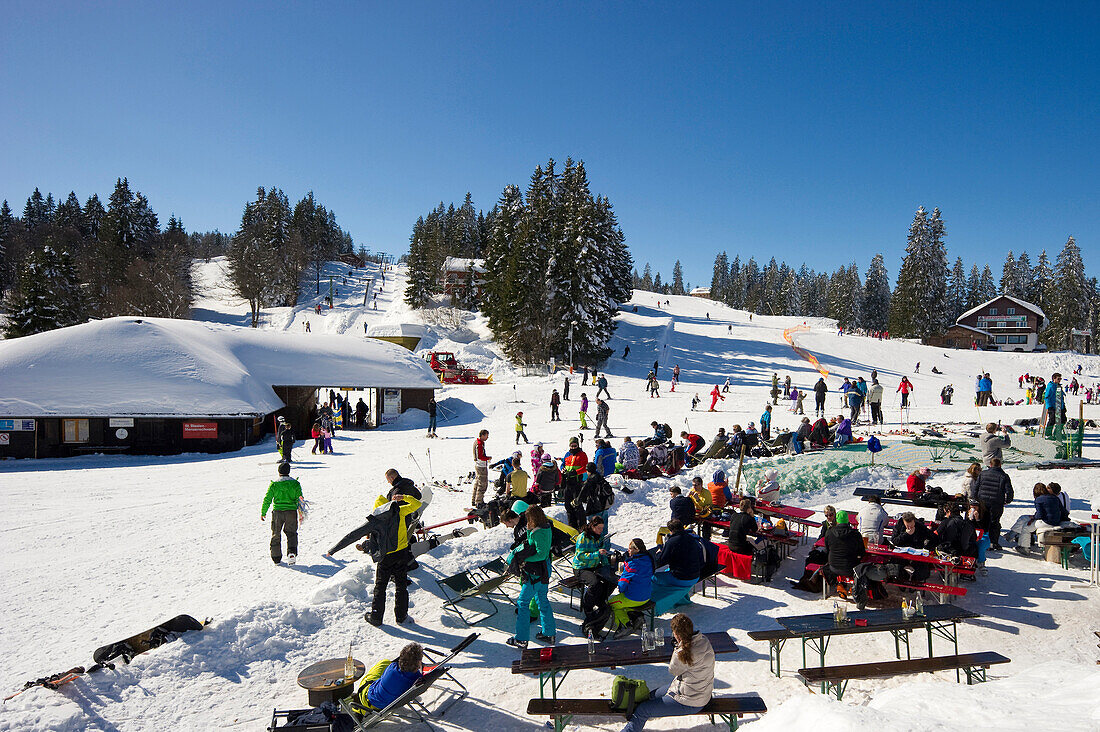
0,317 -> 439,417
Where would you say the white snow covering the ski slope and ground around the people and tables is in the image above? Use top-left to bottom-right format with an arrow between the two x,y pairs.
0,265 -> 1100,732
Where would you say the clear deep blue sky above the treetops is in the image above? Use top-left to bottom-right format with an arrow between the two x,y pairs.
0,2 -> 1100,284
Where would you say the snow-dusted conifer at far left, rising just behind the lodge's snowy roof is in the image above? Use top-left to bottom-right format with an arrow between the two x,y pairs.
4,241 -> 85,338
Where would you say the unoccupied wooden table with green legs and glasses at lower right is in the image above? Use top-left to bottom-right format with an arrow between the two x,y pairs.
749,604 -> 980,693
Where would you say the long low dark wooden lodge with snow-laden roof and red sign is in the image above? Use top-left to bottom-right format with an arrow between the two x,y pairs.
0,317 -> 440,458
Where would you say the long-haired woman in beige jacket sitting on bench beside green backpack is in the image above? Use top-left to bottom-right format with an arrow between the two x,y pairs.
622,613 -> 714,732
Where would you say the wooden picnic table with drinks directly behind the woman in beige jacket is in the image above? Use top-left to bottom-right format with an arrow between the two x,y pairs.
512,632 -> 738,699
